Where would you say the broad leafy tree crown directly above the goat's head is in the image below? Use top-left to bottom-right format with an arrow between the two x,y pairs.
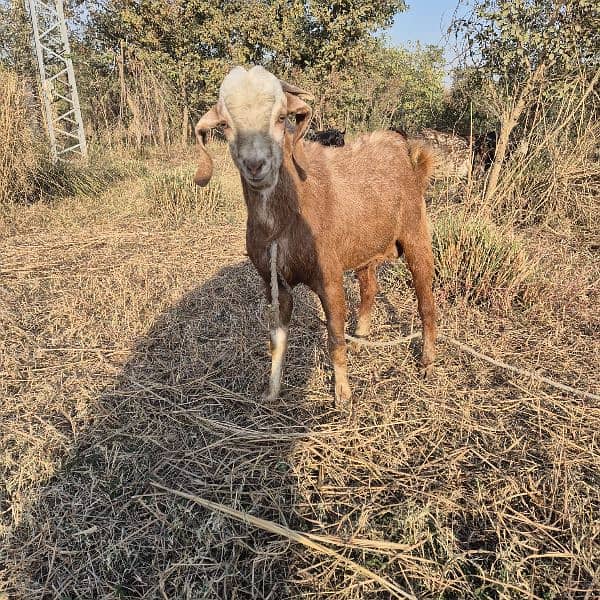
90,0 -> 404,116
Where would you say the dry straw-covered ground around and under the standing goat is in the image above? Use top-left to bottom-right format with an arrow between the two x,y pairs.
0,143 -> 600,600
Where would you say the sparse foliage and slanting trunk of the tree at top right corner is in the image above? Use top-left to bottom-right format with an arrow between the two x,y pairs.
445,0 -> 600,202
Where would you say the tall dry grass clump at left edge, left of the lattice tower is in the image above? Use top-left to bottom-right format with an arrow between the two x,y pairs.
0,66 -> 39,205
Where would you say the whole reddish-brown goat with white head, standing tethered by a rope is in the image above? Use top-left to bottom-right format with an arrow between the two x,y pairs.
194,66 -> 436,404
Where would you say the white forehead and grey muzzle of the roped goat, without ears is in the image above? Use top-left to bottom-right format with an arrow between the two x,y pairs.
219,66 -> 287,191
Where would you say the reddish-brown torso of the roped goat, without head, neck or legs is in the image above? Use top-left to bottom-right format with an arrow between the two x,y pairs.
303,131 -> 433,268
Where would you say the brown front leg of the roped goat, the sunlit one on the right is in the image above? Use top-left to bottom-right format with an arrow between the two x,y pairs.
319,272 -> 352,405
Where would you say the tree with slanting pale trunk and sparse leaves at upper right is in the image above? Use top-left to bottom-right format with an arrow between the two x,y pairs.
452,0 -> 600,199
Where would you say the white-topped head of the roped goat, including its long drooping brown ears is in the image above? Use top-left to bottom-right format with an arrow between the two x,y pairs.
194,66 -> 312,191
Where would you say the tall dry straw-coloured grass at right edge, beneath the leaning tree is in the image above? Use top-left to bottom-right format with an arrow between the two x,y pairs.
478,74 -> 600,226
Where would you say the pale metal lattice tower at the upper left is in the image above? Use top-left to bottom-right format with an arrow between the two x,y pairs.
25,0 -> 87,160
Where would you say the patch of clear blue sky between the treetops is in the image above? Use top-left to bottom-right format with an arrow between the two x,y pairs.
386,0 -> 466,72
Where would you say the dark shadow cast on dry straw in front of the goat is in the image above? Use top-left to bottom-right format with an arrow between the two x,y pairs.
14,262 -> 335,599
